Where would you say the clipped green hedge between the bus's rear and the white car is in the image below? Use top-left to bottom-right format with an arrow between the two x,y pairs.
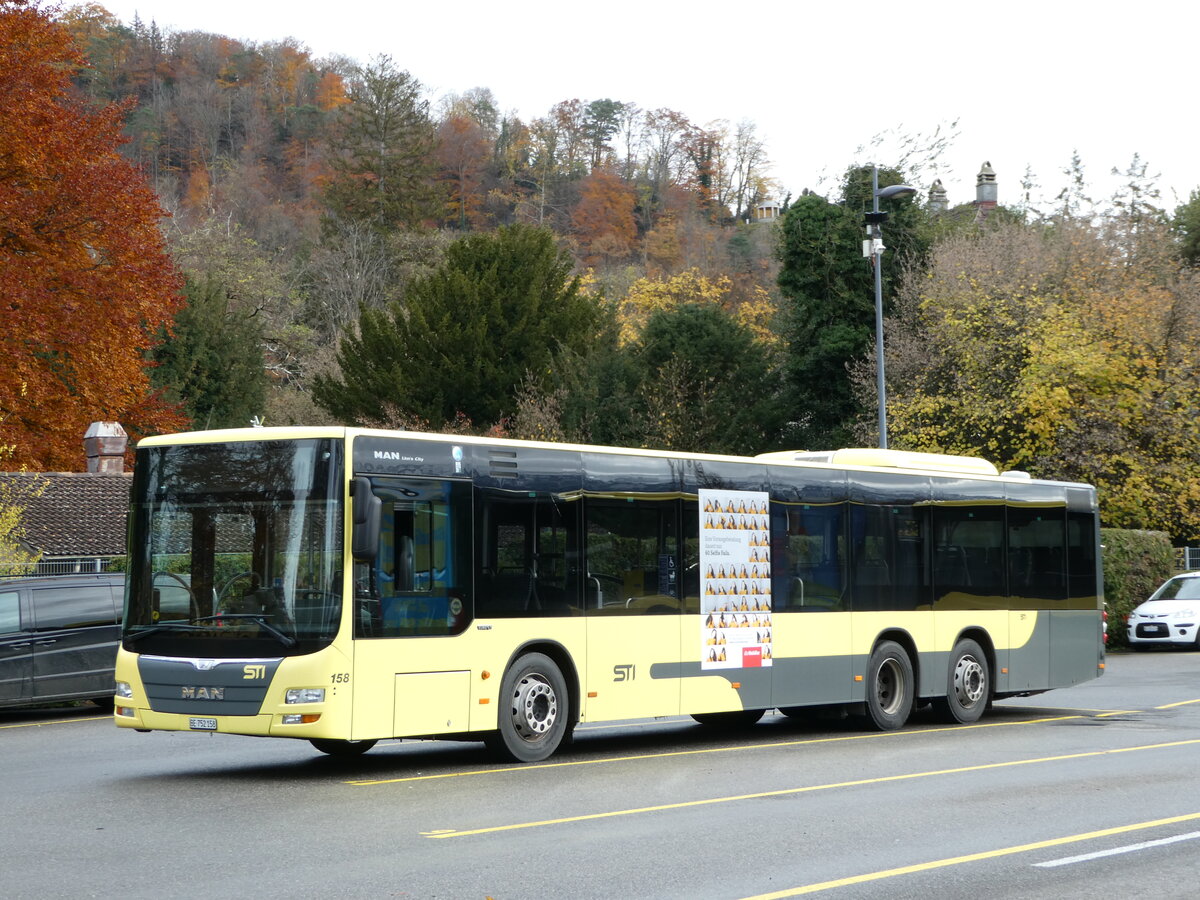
1100,528 -> 1175,648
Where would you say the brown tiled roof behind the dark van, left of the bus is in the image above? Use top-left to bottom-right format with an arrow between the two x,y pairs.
0,472 -> 133,557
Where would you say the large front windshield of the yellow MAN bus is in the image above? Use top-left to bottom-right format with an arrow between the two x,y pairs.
125,439 -> 342,658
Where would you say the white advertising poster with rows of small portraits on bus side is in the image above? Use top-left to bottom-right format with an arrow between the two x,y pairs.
700,490 -> 772,668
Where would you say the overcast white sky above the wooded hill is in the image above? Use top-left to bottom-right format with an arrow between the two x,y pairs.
91,0 -> 1200,210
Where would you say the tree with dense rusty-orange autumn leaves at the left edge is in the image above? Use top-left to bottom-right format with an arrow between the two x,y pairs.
0,0 -> 185,470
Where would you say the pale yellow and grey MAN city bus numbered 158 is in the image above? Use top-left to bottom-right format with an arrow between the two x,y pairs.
114,427 -> 1104,761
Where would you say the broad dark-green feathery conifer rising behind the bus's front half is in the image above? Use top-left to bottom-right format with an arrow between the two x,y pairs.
313,224 -> 600,428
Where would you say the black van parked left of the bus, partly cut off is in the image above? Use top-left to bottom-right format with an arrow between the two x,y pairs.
0,574 -> 125,708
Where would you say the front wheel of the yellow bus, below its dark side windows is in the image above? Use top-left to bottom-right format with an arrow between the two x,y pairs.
485,653 -> 571,762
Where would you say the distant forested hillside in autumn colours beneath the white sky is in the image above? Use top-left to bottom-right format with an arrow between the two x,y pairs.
54,5 -> 774,427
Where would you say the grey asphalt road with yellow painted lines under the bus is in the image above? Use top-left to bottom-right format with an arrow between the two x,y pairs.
0,652 -> 1200,900
